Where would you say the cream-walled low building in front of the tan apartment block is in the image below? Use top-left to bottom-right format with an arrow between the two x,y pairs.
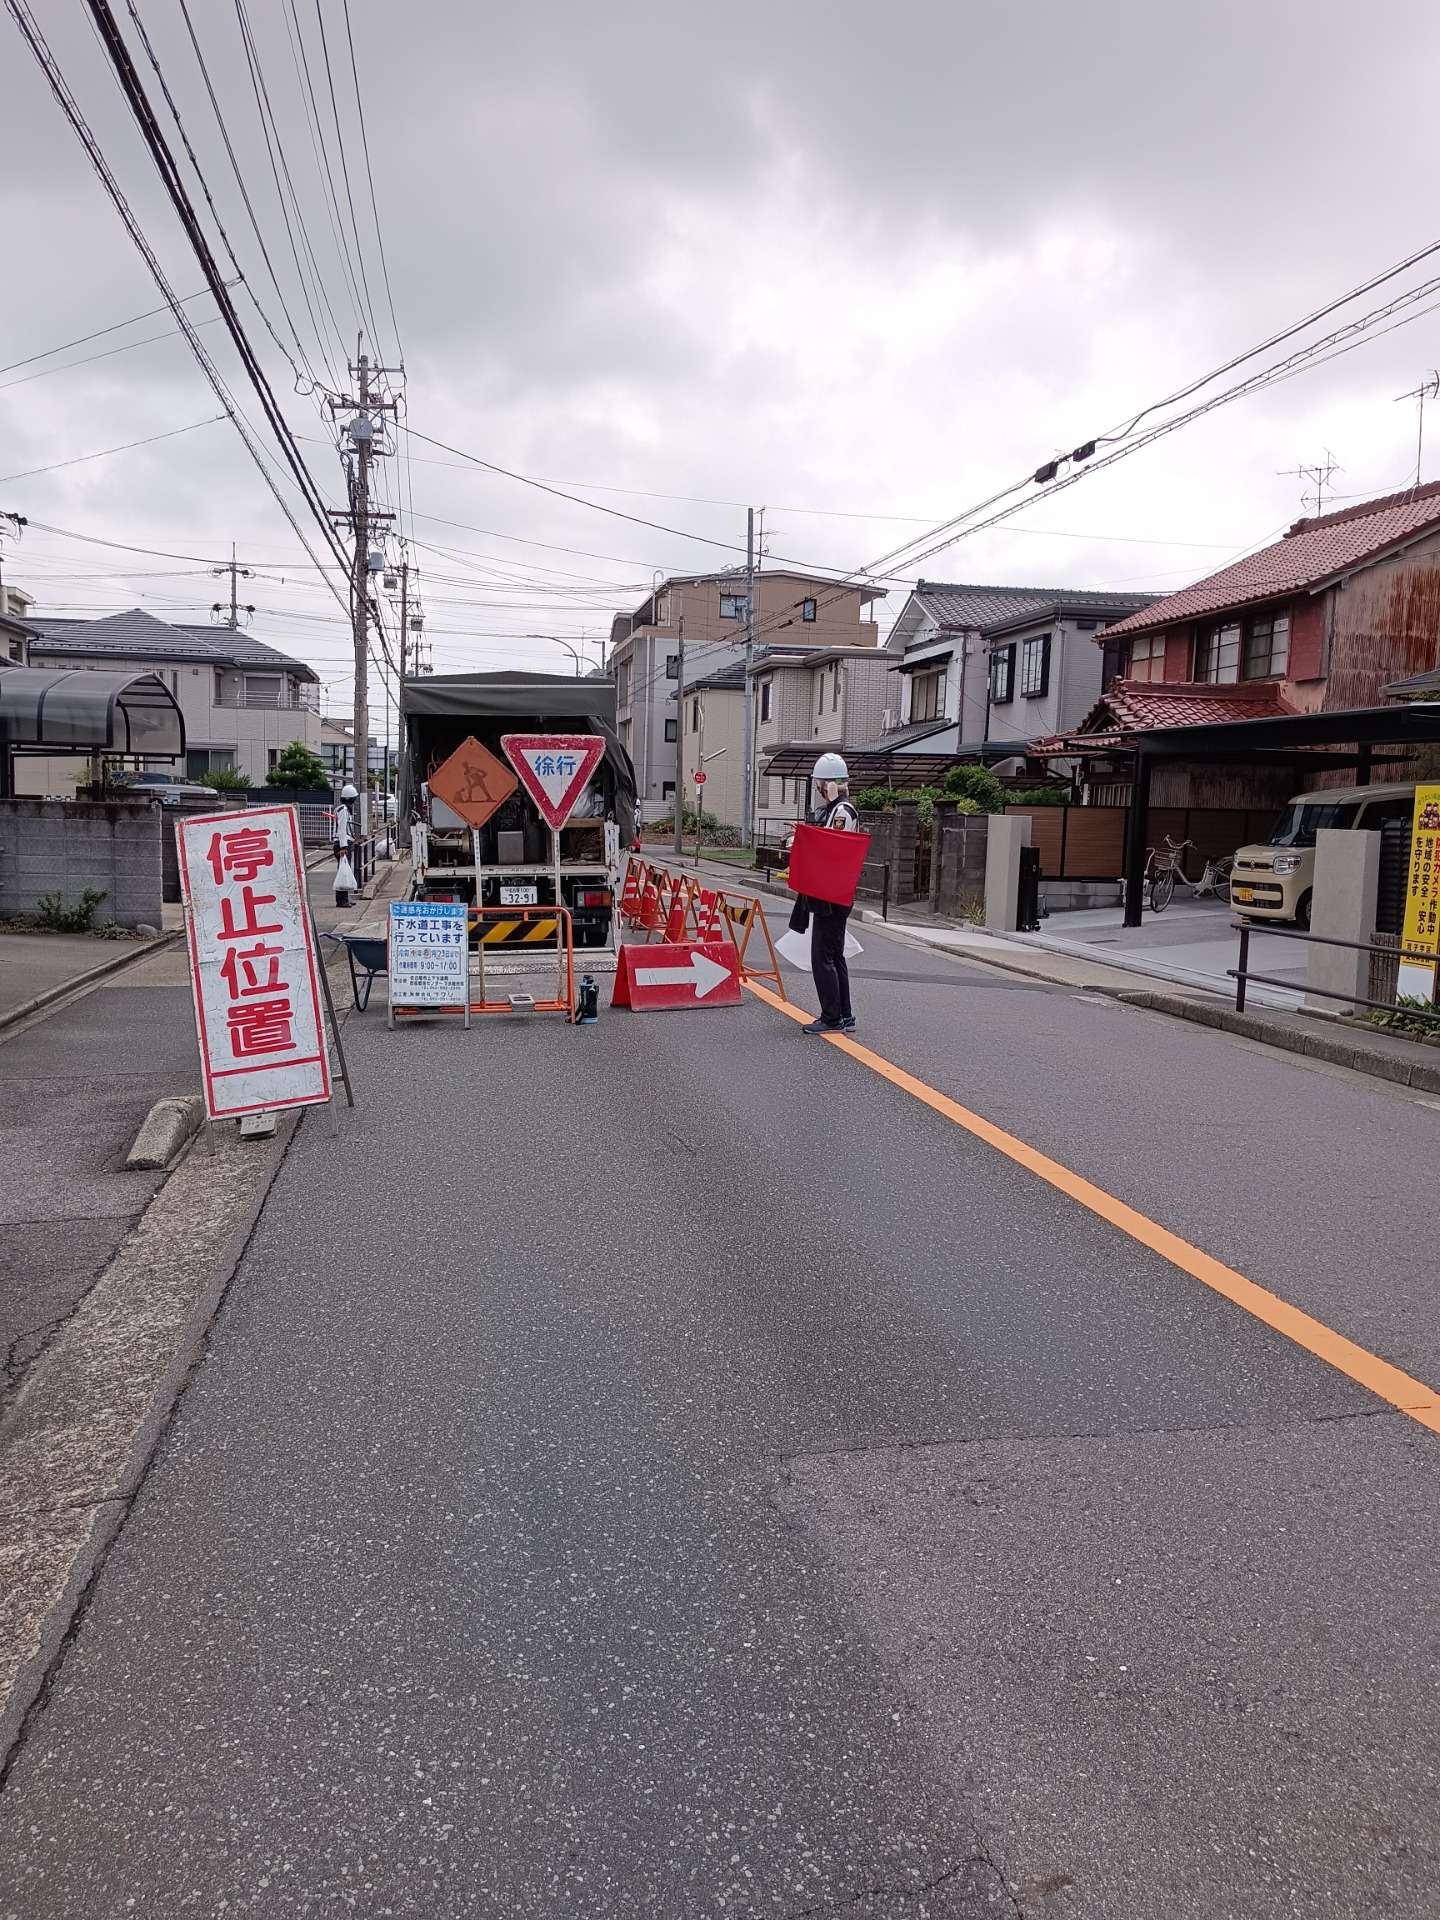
680,639 -> 891,829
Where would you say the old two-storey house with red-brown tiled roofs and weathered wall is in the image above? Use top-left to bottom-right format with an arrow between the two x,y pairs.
1050,482 -> 1440,806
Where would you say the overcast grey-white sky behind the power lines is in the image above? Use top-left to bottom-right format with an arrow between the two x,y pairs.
0,0 -> 1440,725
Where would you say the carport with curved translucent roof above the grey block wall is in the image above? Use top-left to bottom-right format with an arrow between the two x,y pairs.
0,666 -> 184,799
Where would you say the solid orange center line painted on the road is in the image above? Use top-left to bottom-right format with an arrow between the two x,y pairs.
745,979 -> 1440,1434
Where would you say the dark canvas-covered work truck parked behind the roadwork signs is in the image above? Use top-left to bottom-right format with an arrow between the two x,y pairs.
399,672 -> 636,950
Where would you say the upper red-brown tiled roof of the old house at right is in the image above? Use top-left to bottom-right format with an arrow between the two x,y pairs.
1110,480 -> 1440,636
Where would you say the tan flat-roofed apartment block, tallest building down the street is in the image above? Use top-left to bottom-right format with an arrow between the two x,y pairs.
611,568 -> 883,820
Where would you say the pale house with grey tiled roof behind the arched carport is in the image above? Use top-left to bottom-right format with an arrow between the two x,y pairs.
15,607 -> 321,795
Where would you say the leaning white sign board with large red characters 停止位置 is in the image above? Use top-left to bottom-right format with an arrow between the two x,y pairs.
175,806 -> 330,1119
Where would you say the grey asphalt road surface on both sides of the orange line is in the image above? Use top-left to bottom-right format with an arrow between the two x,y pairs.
0,933 -> 1440,1920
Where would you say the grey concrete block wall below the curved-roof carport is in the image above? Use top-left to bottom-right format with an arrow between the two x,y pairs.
0,801 -> 163,927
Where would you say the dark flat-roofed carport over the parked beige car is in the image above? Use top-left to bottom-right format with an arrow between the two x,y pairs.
1112,701 -> 1440,927
